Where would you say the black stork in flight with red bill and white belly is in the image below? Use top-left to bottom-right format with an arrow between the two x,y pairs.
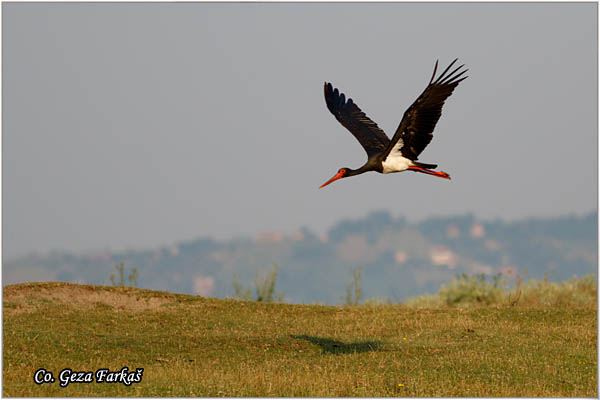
319,58 -> 468,188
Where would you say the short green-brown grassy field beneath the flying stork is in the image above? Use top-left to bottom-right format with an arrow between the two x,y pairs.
3,283 -> 598,397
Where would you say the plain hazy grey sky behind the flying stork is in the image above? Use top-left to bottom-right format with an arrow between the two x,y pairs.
2,3 -> 598,258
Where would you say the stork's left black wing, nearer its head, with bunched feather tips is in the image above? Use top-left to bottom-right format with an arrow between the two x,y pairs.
324,82 -> 390,158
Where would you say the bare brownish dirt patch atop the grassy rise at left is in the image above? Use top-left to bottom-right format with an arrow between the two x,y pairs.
2,282 -> 178,314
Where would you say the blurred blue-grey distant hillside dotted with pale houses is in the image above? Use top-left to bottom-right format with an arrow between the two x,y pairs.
3,211 -> 598,304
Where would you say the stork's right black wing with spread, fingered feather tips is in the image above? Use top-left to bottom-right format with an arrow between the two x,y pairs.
385,59 -> 468,160
